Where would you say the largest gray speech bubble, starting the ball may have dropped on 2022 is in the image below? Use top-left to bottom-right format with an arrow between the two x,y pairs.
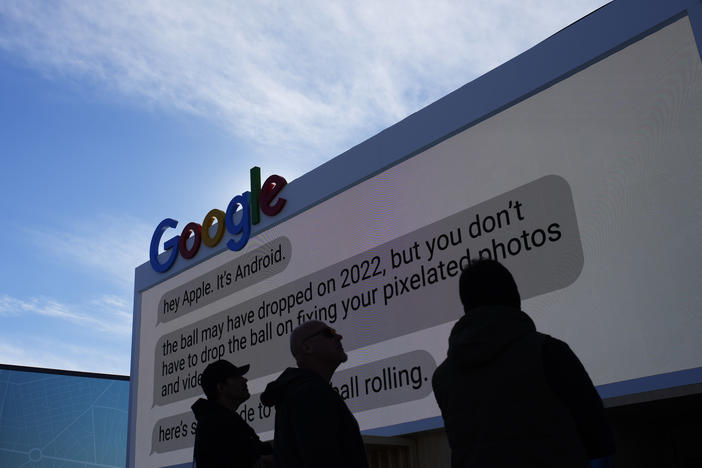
154,175 -> 583,405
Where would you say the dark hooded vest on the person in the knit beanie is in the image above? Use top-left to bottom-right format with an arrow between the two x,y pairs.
432,306 -> 603,468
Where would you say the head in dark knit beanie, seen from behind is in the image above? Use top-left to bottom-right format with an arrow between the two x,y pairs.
459,258 -> 521,313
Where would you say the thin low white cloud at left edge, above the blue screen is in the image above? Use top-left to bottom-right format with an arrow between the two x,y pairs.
0,294 -> 132,341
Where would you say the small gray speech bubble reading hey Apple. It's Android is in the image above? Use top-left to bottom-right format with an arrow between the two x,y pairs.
157,237 -> 292,323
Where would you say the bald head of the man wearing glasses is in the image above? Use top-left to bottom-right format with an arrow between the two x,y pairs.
290,320 -> 348,372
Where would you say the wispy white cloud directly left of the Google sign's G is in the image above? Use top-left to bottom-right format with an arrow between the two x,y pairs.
28,215 -> 154,295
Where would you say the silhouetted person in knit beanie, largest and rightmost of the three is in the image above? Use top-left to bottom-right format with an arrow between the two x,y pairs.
432,260 -> 614,468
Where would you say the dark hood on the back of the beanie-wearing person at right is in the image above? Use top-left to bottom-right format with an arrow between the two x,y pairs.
448,306 -> 536,367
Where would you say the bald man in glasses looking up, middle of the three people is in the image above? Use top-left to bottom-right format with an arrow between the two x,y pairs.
261,321 -> 368,468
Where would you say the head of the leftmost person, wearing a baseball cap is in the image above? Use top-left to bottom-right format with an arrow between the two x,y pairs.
201,359 -> 251,408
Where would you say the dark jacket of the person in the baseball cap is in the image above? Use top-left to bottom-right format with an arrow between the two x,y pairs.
191,398 -> 272,468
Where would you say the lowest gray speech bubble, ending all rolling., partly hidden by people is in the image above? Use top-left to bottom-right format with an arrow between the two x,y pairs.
151,350 -> 436,453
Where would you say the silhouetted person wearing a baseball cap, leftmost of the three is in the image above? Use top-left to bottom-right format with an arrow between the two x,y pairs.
192,360 -> 273,468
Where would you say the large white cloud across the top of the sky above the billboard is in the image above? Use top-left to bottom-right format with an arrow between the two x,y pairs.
0,0 -> 606,164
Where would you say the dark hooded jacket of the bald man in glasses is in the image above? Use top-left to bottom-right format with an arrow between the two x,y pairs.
261,368 -> 368,468
